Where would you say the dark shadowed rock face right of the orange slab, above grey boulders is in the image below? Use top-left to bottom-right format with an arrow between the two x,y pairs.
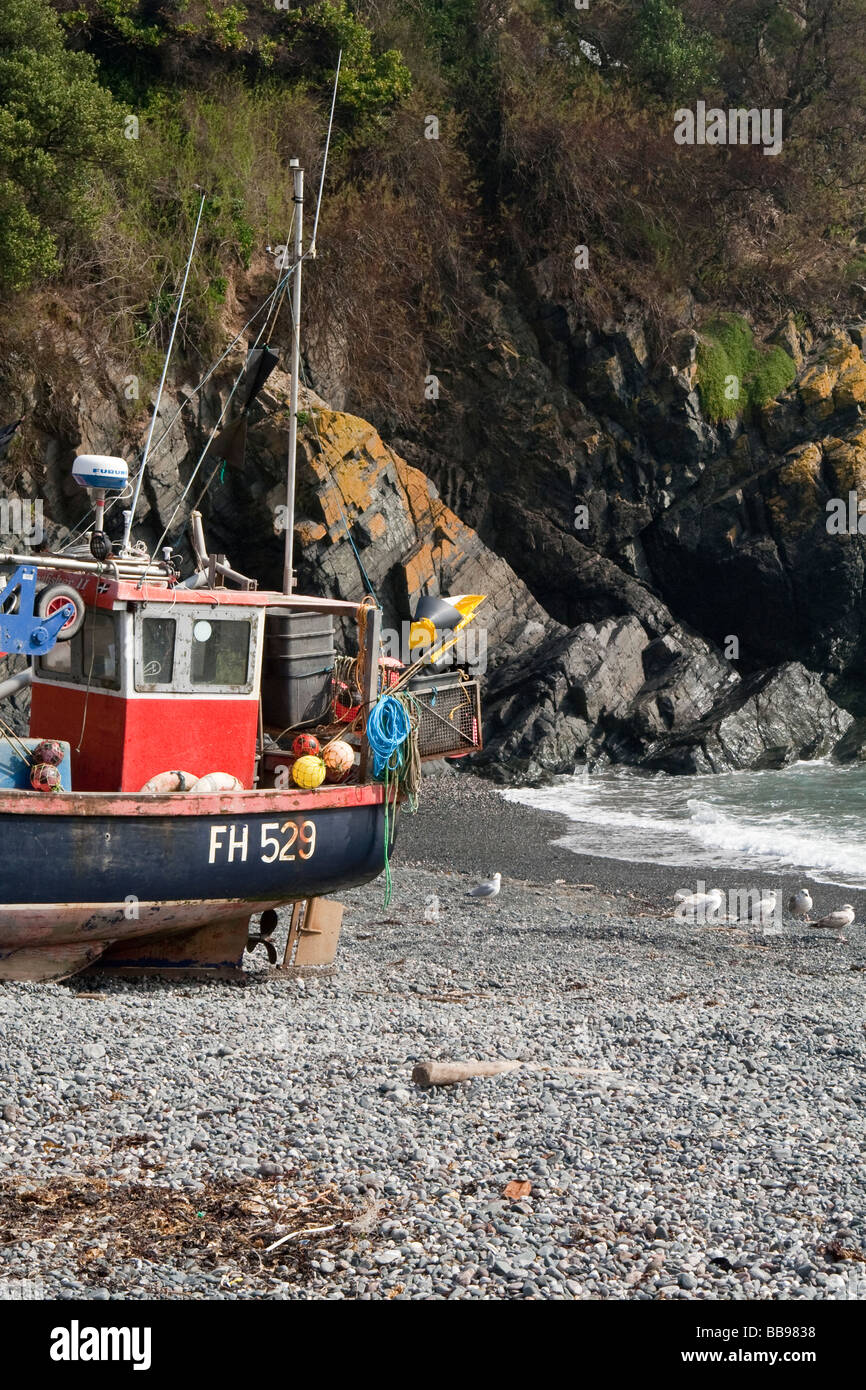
400,277 -> 866,713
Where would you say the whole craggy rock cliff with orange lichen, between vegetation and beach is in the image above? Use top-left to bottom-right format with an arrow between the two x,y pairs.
0,307 -> 866,778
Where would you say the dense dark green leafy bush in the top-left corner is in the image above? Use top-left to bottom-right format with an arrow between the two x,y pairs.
0,0 -> 125,291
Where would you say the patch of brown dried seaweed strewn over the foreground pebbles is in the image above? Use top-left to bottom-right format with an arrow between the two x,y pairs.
0,1176 -> 364,1293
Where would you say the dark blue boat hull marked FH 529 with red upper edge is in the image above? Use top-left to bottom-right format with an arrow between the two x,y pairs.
0,785 -> 396,980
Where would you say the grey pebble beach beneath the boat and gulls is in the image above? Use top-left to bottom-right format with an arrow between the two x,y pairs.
0,774 -> 866,1300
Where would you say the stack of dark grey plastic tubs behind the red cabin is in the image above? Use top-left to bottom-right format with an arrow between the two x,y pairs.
261,607 -> 336,728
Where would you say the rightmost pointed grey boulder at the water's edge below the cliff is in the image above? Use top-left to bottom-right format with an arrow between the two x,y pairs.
642,662 -> 852,773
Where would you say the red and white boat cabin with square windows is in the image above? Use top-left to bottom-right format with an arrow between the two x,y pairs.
31,571 -> 353,791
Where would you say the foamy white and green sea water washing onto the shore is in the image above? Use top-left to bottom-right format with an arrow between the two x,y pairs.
506,762 -> 866,888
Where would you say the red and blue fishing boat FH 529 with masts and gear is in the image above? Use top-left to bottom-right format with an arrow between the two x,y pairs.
0,161 -> 480,980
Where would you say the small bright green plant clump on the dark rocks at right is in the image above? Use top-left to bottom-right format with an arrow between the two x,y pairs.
698,314 -> 796,421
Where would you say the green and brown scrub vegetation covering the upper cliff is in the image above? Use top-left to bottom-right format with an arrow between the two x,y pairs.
0,0 -> 866,418
